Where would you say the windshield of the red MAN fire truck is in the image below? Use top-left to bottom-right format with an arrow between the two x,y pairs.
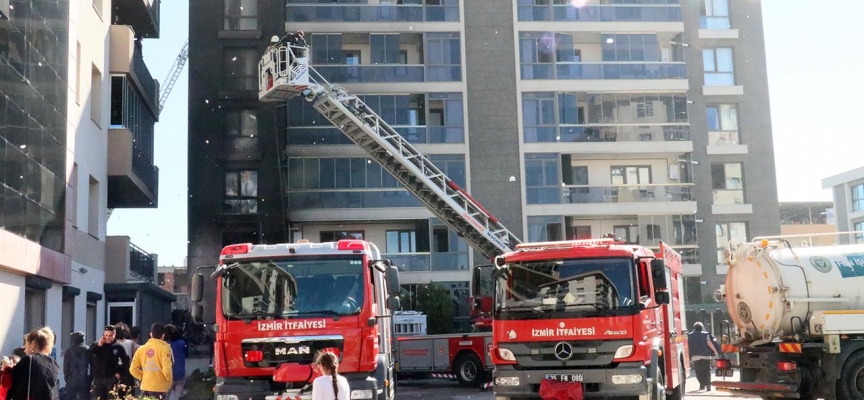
221,256 -> 363,320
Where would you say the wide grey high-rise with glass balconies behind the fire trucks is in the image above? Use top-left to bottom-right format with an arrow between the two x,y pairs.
189,0 -> 779,324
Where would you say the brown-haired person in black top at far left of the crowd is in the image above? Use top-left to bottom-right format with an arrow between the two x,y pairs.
6,327 -> 60,400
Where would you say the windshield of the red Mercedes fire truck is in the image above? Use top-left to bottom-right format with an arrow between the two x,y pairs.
495,258 -> 636,319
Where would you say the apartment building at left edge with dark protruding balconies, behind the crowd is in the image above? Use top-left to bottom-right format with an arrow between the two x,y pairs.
0,0 -> 167,363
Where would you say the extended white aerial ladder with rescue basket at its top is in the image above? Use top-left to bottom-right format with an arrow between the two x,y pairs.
258,42 -> 520,259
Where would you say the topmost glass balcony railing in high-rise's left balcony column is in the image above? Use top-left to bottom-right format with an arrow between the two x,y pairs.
285,4 -> 459,22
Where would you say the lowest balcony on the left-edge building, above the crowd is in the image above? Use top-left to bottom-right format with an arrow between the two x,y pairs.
105,236 -> 158,283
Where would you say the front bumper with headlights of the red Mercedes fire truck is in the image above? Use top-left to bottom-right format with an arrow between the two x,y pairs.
492,363 -> 651,398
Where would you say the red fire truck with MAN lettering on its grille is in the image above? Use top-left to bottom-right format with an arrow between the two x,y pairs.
192,240 -> 399,400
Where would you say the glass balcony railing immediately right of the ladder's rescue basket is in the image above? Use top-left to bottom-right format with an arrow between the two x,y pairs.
315,64 -> 462,83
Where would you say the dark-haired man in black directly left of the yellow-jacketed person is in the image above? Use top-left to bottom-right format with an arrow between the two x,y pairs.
89,325 -> 129,400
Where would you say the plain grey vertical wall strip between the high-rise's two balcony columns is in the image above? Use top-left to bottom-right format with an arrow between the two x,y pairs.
462,0 -> 523,247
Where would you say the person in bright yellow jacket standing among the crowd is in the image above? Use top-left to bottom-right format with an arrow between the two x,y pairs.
129,323 -> 174,400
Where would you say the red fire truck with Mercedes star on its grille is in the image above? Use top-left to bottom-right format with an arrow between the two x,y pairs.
491,239 -> 688,399
